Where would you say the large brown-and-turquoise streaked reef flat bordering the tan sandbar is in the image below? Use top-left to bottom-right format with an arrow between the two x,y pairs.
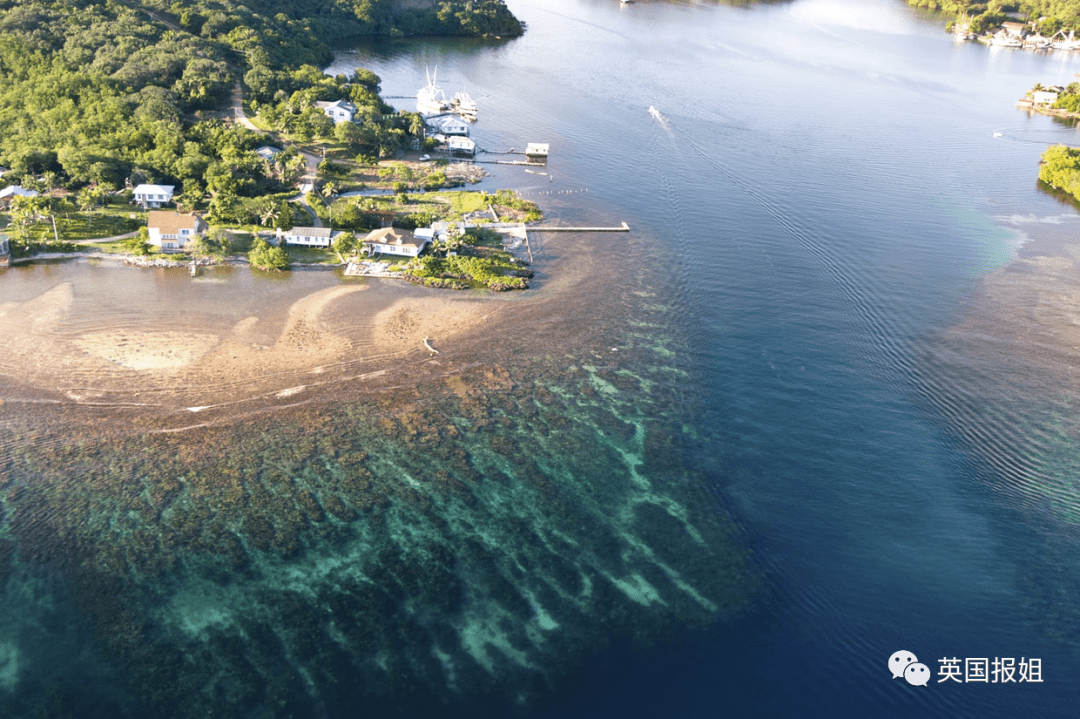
0,234 -> 767,717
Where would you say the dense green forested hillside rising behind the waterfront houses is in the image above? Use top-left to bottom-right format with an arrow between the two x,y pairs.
0,0 -> 522,195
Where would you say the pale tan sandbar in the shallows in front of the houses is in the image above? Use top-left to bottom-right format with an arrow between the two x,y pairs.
0,275 -> 507,406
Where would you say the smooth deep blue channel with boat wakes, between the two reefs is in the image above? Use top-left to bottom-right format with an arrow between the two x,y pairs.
328,0 -> 1080,717
